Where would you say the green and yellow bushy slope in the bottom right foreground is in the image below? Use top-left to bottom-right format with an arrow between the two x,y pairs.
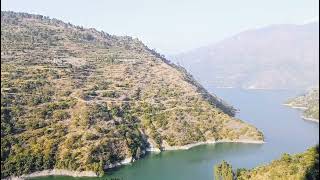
214,146 -> 319,180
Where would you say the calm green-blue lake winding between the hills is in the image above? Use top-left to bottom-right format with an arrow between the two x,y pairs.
34,88 -> 319,180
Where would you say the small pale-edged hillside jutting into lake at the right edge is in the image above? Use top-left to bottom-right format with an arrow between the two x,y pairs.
286,89 -> 319,122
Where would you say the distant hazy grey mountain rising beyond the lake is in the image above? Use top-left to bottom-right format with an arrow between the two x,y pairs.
172,22 -> 319,89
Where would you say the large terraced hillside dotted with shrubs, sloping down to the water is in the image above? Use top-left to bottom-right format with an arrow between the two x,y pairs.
1,12 -> 263,178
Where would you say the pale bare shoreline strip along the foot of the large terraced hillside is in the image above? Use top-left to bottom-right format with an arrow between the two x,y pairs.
4,140 -> 265,180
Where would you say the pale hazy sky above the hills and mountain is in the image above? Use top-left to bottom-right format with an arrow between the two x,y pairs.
1,0 -> 319,55
